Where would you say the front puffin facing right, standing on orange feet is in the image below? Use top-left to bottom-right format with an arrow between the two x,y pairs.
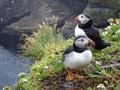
62,35 -> 93,81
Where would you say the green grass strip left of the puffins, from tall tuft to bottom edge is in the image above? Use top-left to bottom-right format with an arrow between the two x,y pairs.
15,23 -> 73,90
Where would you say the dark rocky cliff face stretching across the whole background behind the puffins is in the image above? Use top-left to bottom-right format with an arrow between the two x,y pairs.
0,0 -> 120,48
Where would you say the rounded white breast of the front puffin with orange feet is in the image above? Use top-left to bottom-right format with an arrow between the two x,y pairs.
64,50 -> 92,70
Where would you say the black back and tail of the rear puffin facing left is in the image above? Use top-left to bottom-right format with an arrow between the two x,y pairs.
78,20 -> 110,50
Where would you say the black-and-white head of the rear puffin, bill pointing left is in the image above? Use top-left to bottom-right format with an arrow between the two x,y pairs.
75,13 -> 92,28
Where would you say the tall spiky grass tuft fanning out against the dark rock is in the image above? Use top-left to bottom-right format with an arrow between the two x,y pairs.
23,22 -> 69,60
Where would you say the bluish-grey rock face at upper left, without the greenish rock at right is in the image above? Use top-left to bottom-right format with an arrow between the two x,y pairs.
0,0 -> 87,48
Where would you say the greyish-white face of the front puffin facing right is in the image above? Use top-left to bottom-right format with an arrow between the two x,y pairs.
75,37 -> 89,48
